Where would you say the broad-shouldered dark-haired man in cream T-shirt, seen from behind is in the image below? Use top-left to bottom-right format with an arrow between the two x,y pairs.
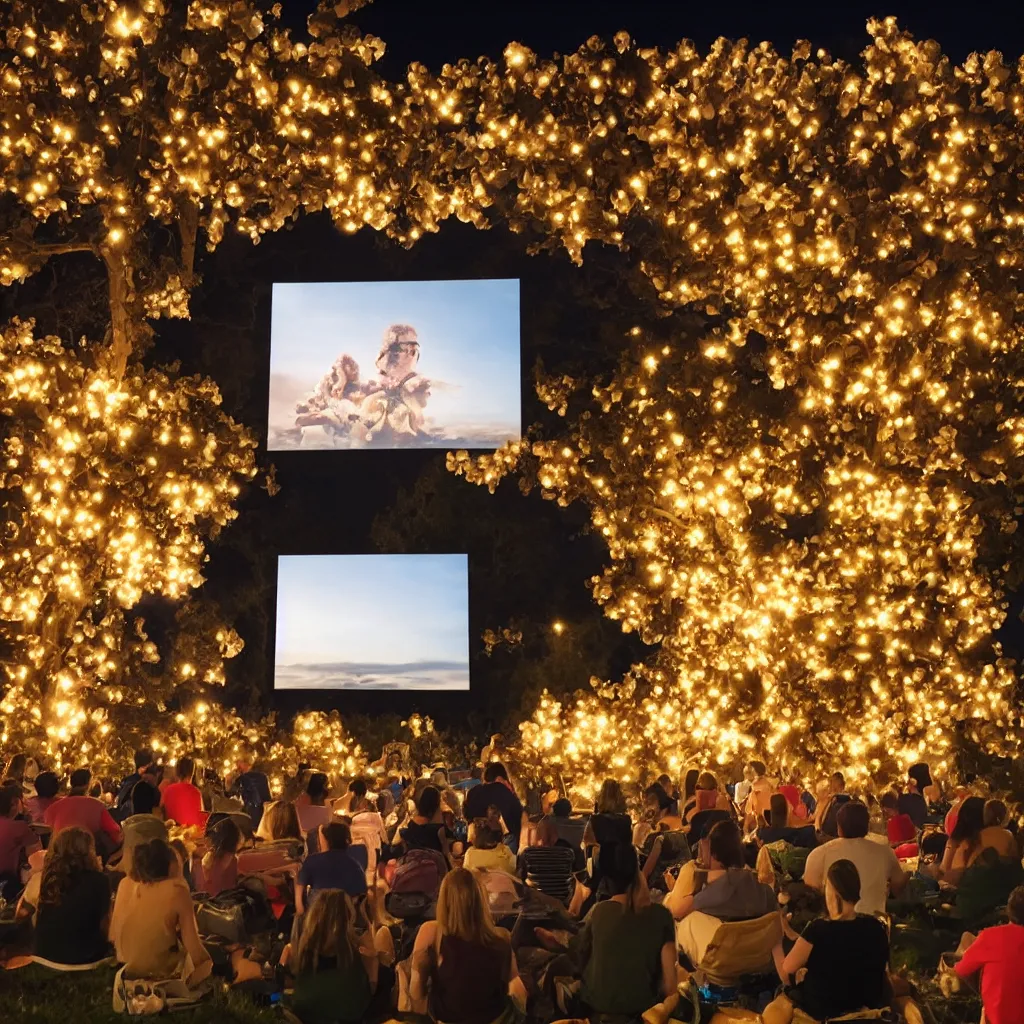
804,800 -> 907,913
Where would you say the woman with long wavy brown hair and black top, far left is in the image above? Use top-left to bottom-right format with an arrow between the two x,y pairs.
35,826 -> 111,964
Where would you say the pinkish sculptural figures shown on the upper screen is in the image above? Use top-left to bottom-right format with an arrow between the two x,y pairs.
295,324 -> 430,447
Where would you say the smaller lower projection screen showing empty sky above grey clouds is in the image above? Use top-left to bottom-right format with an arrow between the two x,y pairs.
273,555 -> 469,690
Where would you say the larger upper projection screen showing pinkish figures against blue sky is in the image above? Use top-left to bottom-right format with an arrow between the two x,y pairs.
267,280 -> 521,452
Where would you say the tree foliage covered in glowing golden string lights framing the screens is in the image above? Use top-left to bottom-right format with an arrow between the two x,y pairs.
0,0 -> 1024,785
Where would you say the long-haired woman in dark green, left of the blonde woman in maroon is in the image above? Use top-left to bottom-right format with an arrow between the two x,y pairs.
288,889 -> 385,1024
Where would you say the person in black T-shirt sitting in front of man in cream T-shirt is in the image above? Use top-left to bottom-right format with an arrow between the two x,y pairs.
763,860 -> 892,1024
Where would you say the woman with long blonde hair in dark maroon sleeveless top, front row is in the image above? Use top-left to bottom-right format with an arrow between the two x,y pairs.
410,867 -> 526,1024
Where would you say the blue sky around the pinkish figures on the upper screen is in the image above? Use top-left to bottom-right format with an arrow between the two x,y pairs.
270,279 -> 520,428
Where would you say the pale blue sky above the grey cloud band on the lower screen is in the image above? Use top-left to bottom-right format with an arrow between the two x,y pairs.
275,555 -> 469,666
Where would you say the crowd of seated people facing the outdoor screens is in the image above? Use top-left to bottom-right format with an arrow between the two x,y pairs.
0,751 -> 1024,1024
